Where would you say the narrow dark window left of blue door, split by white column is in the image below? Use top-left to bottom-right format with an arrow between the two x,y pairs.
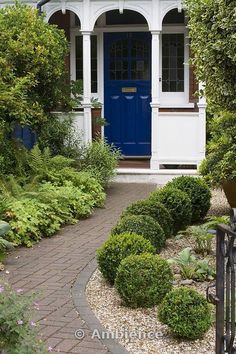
75,36 -> 98,93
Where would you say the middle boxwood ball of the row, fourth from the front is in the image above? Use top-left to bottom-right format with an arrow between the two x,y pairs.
111,215 -> 166,252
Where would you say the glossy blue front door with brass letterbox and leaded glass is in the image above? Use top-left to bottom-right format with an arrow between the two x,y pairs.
104,32 -> 151,156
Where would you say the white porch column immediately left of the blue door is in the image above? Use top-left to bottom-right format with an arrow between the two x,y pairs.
81,31 -> 92,143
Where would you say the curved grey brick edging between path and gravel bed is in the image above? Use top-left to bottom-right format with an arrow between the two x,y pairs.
71,258 -> 129,354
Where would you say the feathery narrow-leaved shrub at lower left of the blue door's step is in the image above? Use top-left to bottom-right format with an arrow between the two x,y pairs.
78,139 -> 121,187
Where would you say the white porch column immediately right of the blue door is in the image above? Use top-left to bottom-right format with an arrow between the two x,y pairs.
151,31 -> 161,170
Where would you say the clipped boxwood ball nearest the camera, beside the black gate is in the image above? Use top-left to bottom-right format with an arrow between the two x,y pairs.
158,287 -> 212,339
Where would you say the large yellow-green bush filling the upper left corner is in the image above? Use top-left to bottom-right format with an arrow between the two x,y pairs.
0,2 -> 68,127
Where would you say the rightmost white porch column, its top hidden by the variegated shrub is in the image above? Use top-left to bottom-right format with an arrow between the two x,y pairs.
198,82 -> 207,165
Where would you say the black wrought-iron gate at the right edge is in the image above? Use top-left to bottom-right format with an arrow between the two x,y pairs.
208,209 -> 236,354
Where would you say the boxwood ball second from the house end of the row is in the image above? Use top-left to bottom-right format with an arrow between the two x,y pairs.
150,187 -> 192,233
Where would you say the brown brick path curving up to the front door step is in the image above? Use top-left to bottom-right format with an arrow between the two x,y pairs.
6,184 -> 154,354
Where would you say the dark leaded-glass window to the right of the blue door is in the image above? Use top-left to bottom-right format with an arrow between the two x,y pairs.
162,33 -> 184,92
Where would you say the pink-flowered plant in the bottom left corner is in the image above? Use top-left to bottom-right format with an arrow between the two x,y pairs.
0,283 -> 48,354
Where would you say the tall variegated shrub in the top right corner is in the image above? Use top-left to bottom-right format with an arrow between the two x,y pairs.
185,0 -> 236,112
